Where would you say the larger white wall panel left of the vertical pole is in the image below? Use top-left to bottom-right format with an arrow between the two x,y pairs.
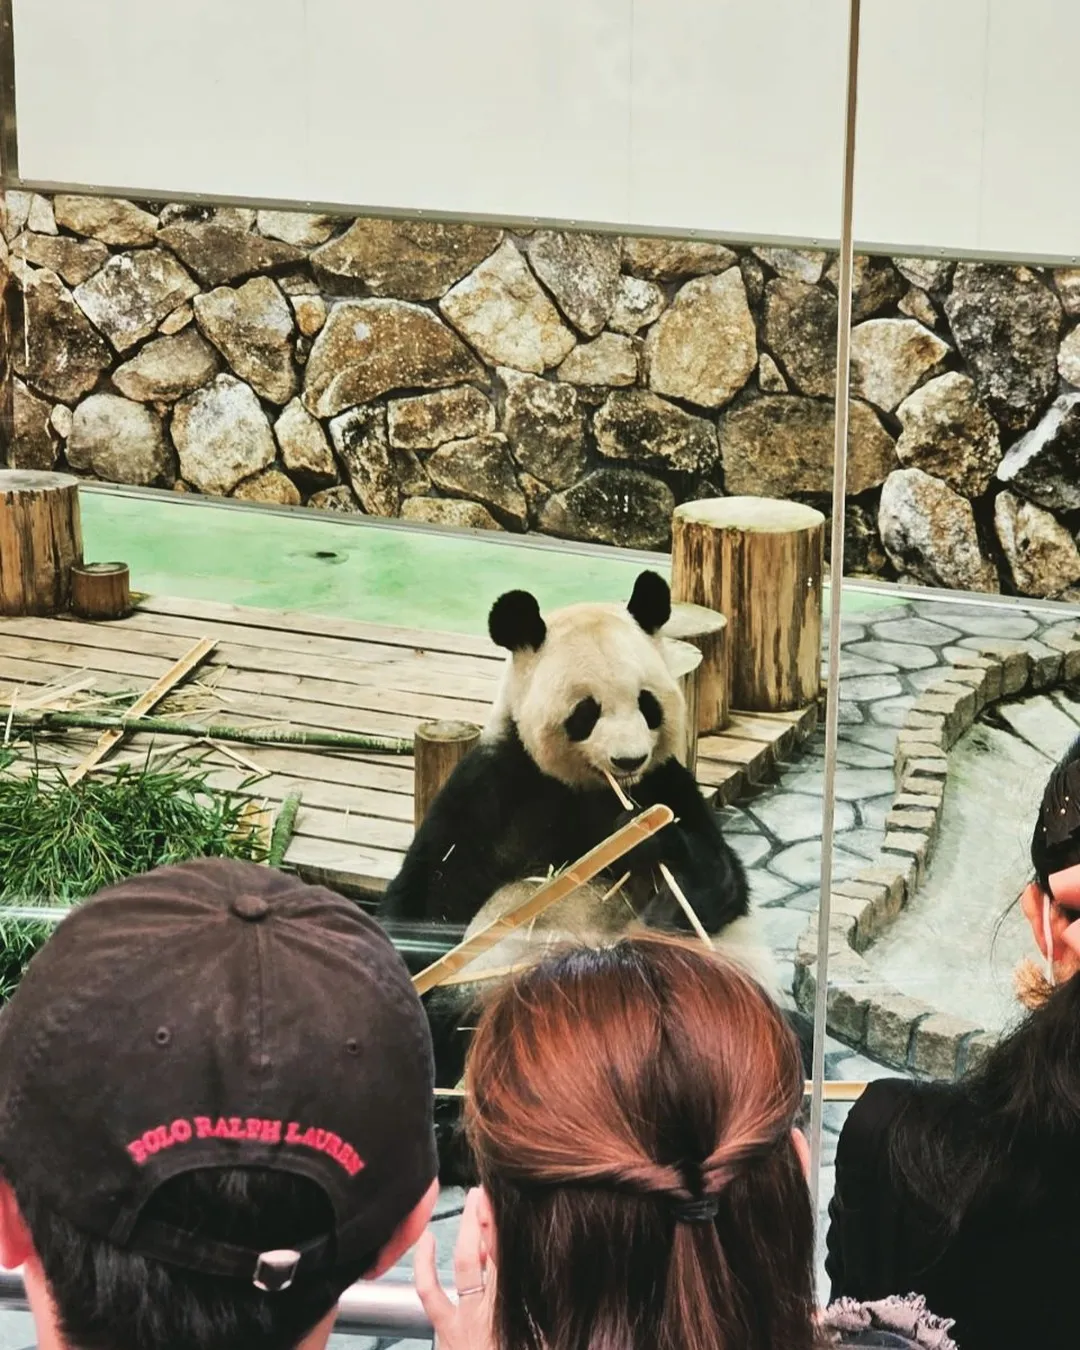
14,0 -> 846,235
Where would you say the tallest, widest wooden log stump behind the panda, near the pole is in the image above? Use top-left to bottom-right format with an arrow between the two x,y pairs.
671,497 -> 825,713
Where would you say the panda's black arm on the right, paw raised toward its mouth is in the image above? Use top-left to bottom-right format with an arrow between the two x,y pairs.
630,759 -> 749,933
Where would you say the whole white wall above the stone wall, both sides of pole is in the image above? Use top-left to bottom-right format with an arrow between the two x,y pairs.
12,0 -> 1080,257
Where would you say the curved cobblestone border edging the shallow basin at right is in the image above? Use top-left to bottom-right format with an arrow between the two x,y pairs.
794,630 -> 1080,1080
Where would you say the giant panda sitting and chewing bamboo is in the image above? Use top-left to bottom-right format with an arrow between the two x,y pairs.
379,571 -> 772,1180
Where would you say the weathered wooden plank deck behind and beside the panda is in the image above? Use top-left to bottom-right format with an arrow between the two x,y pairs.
0,598 -> 817,898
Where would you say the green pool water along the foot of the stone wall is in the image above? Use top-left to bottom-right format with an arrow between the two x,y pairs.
80,486 -> 900,635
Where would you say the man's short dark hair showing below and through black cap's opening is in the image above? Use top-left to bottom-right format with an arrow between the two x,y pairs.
12,1168 -> 378,1350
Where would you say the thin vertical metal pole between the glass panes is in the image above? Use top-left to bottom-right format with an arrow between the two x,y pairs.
810,0 -> 861,1214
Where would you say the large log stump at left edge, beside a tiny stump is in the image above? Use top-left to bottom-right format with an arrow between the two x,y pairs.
0,468 -> 82,614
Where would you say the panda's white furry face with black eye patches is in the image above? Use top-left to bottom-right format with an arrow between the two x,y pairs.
489,578 -> 686,787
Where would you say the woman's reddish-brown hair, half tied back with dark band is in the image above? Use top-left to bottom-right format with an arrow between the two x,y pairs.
466,936 -> 817,1350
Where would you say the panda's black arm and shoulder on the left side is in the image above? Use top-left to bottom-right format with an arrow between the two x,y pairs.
378,745 -> 537,923
